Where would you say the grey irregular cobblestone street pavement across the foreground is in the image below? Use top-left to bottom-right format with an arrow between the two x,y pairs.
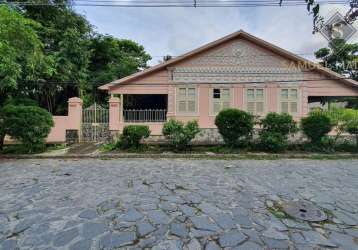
0,159 -> 358,250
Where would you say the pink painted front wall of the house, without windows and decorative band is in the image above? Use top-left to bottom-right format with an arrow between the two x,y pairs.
108,35 -> 358,134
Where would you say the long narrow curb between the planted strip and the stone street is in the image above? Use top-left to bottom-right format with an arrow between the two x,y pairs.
0,153 -> 358,160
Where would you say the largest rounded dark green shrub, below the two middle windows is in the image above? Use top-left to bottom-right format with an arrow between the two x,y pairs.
215,109 -> 254,147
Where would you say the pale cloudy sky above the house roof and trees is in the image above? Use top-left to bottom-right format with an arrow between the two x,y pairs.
75,3 -> 358,65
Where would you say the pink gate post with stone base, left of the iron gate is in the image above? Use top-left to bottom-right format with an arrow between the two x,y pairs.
66,97 -> 82,142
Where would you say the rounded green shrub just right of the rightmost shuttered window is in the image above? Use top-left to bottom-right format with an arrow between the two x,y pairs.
301,111 -> 333,145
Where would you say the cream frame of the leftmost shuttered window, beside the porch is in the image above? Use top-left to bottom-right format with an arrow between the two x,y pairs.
175,85 -> 199,116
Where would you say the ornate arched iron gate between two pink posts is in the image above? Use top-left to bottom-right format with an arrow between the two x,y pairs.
81,103 -> 110,142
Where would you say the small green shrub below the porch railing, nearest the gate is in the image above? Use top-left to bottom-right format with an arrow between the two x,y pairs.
116,125 -> 150,149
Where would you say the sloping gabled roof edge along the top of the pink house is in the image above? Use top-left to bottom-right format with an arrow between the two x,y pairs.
99,30 -> 358,90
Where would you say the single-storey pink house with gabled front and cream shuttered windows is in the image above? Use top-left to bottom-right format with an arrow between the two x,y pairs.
100,31 -> 358,139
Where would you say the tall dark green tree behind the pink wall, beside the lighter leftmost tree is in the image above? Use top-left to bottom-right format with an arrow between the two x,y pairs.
10,0 -> 92,113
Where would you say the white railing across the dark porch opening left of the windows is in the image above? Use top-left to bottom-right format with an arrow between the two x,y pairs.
123,109 -> 167,122
